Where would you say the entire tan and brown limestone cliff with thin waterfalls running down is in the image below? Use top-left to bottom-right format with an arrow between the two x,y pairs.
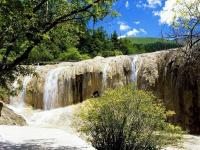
10,49 -> 200,133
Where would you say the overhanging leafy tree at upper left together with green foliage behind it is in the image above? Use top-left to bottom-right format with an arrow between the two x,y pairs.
0,0 -> 116,90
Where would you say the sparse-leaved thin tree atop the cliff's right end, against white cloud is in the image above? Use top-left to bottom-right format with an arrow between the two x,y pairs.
160,0 -> 200,69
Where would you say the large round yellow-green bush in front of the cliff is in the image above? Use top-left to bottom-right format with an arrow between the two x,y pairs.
75,86 -> 182,150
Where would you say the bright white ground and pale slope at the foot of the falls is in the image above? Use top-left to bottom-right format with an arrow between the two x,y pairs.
4,105 -> 94,150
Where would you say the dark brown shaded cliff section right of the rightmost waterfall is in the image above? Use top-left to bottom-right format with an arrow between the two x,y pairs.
138,49 -> 200,133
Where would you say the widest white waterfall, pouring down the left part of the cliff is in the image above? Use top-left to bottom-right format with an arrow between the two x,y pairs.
43,67 -> 64,110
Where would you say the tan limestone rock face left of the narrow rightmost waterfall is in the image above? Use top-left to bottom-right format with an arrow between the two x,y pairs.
25,56 -> 132,109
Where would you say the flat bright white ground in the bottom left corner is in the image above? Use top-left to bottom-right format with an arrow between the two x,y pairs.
0,126 -> 94,150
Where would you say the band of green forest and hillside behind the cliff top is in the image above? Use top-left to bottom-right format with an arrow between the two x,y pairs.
23,26 -> 181,63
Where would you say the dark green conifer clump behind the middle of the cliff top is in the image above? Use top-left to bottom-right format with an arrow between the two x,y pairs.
77,27 -> 126,57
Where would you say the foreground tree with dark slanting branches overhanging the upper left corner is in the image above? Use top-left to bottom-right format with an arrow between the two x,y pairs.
0,0 -> 116,86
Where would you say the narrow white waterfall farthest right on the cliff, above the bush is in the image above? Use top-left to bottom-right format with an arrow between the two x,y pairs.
131,55 -> 138,82
